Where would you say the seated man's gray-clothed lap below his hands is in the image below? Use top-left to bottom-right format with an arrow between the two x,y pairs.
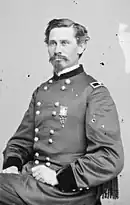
0,173 -> 96,205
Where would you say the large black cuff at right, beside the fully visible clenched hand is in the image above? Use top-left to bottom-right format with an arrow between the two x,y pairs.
57,165 -> 78,192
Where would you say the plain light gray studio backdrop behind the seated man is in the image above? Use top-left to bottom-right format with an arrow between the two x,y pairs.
0,0 -> 130,205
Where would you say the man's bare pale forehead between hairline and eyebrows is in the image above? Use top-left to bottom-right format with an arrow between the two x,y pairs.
49,27 -> 76,41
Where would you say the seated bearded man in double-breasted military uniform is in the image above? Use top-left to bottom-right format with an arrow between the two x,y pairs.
0,19 -> 124,205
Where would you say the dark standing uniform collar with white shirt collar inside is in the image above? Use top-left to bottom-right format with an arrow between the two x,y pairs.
53,64 -> 84,80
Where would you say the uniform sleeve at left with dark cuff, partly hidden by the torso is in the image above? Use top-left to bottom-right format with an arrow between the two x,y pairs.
3,91 -> 36,171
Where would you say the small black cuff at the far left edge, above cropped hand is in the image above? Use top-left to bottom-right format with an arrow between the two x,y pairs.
3,157 -> 22,171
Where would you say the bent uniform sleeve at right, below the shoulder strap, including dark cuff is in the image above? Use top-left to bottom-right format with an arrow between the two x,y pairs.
57,87 -> 124,191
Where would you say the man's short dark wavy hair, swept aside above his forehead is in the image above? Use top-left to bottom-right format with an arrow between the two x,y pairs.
44,18 -> 90,57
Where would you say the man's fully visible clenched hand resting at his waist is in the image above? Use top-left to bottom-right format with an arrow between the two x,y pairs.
32,165 -> 58,186
